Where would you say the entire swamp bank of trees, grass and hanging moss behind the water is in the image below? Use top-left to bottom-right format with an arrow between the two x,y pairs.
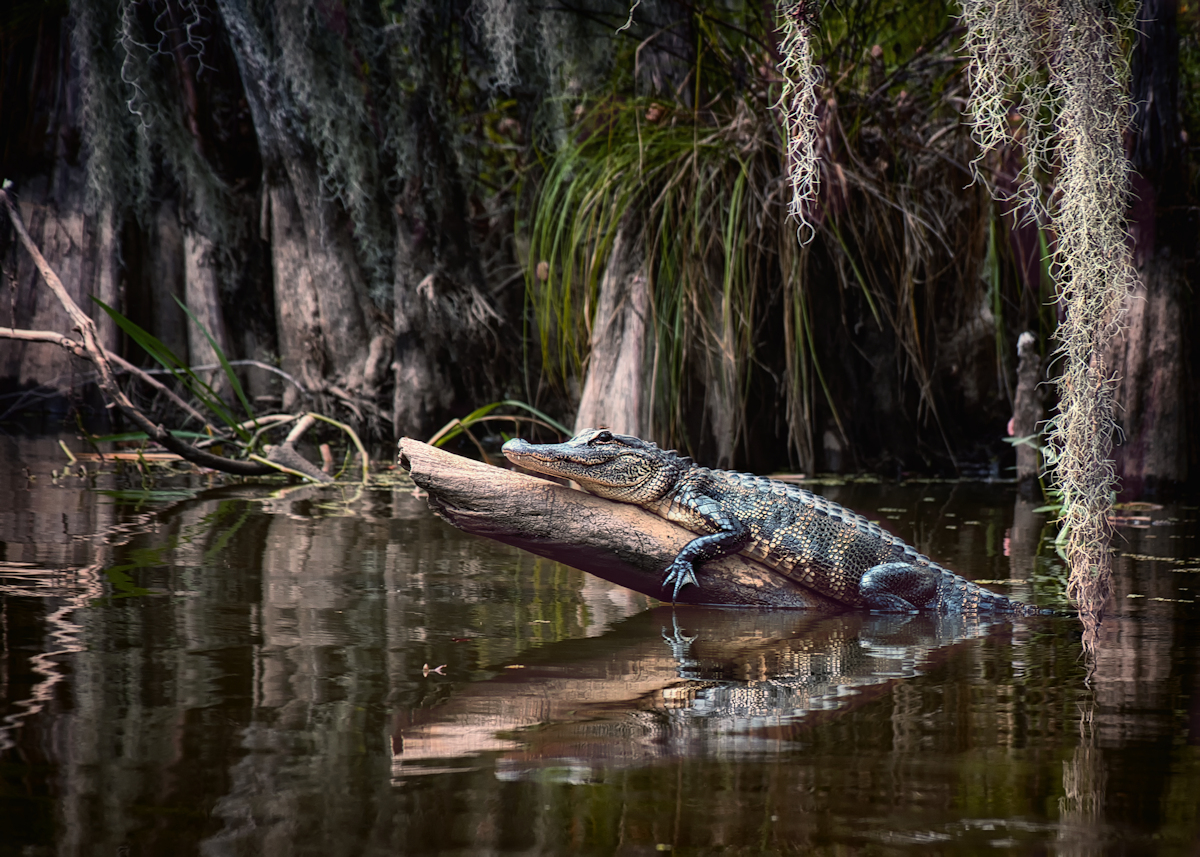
0,0 -> 1200,619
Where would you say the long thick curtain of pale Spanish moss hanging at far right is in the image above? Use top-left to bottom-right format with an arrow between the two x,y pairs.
964,0 -> 1136,616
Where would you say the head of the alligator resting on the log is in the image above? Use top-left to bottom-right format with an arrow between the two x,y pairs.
503,429 -> 692,505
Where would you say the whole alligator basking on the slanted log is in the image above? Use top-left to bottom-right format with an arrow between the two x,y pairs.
503,429 -> 1042,616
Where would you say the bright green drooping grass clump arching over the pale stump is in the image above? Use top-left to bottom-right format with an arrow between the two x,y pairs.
527,96 -> 782,460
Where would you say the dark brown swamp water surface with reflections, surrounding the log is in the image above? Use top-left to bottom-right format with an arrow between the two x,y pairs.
0,439 -> 1200,856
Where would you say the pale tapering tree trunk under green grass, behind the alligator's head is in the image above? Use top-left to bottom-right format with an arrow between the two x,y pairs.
575,215 -> 652,437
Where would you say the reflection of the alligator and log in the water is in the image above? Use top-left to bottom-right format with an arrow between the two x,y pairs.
392,606 -> 1013,780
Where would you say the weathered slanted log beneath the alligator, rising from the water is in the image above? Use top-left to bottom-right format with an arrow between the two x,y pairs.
400,438 -> 845,612
